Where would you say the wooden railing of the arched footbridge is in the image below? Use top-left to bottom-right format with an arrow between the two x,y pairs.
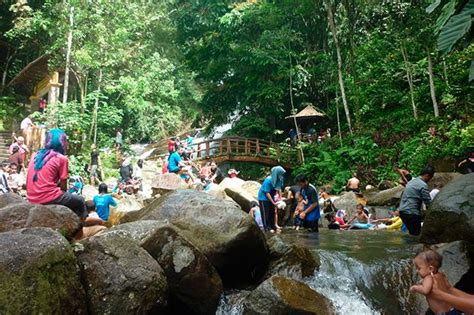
193,137 -> 300,167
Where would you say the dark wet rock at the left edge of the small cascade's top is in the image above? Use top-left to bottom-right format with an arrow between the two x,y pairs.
267,236 -> 321,280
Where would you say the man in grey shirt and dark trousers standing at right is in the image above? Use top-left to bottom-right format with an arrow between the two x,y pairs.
400,166 -> 435,235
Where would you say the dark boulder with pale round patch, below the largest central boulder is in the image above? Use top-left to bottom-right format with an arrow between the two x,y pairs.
114,220 -> 223,314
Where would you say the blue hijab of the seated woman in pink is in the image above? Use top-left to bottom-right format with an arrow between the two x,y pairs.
33,129 -> 67,182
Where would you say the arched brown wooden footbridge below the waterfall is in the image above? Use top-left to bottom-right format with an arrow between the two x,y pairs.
193,137 -> 301,169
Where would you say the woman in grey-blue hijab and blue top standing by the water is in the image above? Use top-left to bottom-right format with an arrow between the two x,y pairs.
258,166 -> 286,233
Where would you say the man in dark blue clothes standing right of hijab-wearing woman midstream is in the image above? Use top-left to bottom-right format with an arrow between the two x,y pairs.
296,175 -> 321,232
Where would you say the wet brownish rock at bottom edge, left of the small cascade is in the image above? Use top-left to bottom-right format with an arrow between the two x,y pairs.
243,276 -> 335,315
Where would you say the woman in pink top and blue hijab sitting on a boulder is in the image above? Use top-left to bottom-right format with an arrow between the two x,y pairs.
26,129 -> 87,219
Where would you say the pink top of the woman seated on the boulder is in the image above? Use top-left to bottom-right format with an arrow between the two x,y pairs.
26,153 -> 69,204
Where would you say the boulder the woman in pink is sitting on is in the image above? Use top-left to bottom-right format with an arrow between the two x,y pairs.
0,194 -> 81,239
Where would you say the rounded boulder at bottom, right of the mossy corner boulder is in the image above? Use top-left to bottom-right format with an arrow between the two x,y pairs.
76,231 -> 167,314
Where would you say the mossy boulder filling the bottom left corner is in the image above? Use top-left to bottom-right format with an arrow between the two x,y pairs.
0,228 -> 87,314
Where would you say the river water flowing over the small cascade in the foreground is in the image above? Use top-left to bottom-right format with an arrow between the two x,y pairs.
217,229 -> 426,315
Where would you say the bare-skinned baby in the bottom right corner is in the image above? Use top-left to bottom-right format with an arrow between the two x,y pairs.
410,249 -> 461,315
